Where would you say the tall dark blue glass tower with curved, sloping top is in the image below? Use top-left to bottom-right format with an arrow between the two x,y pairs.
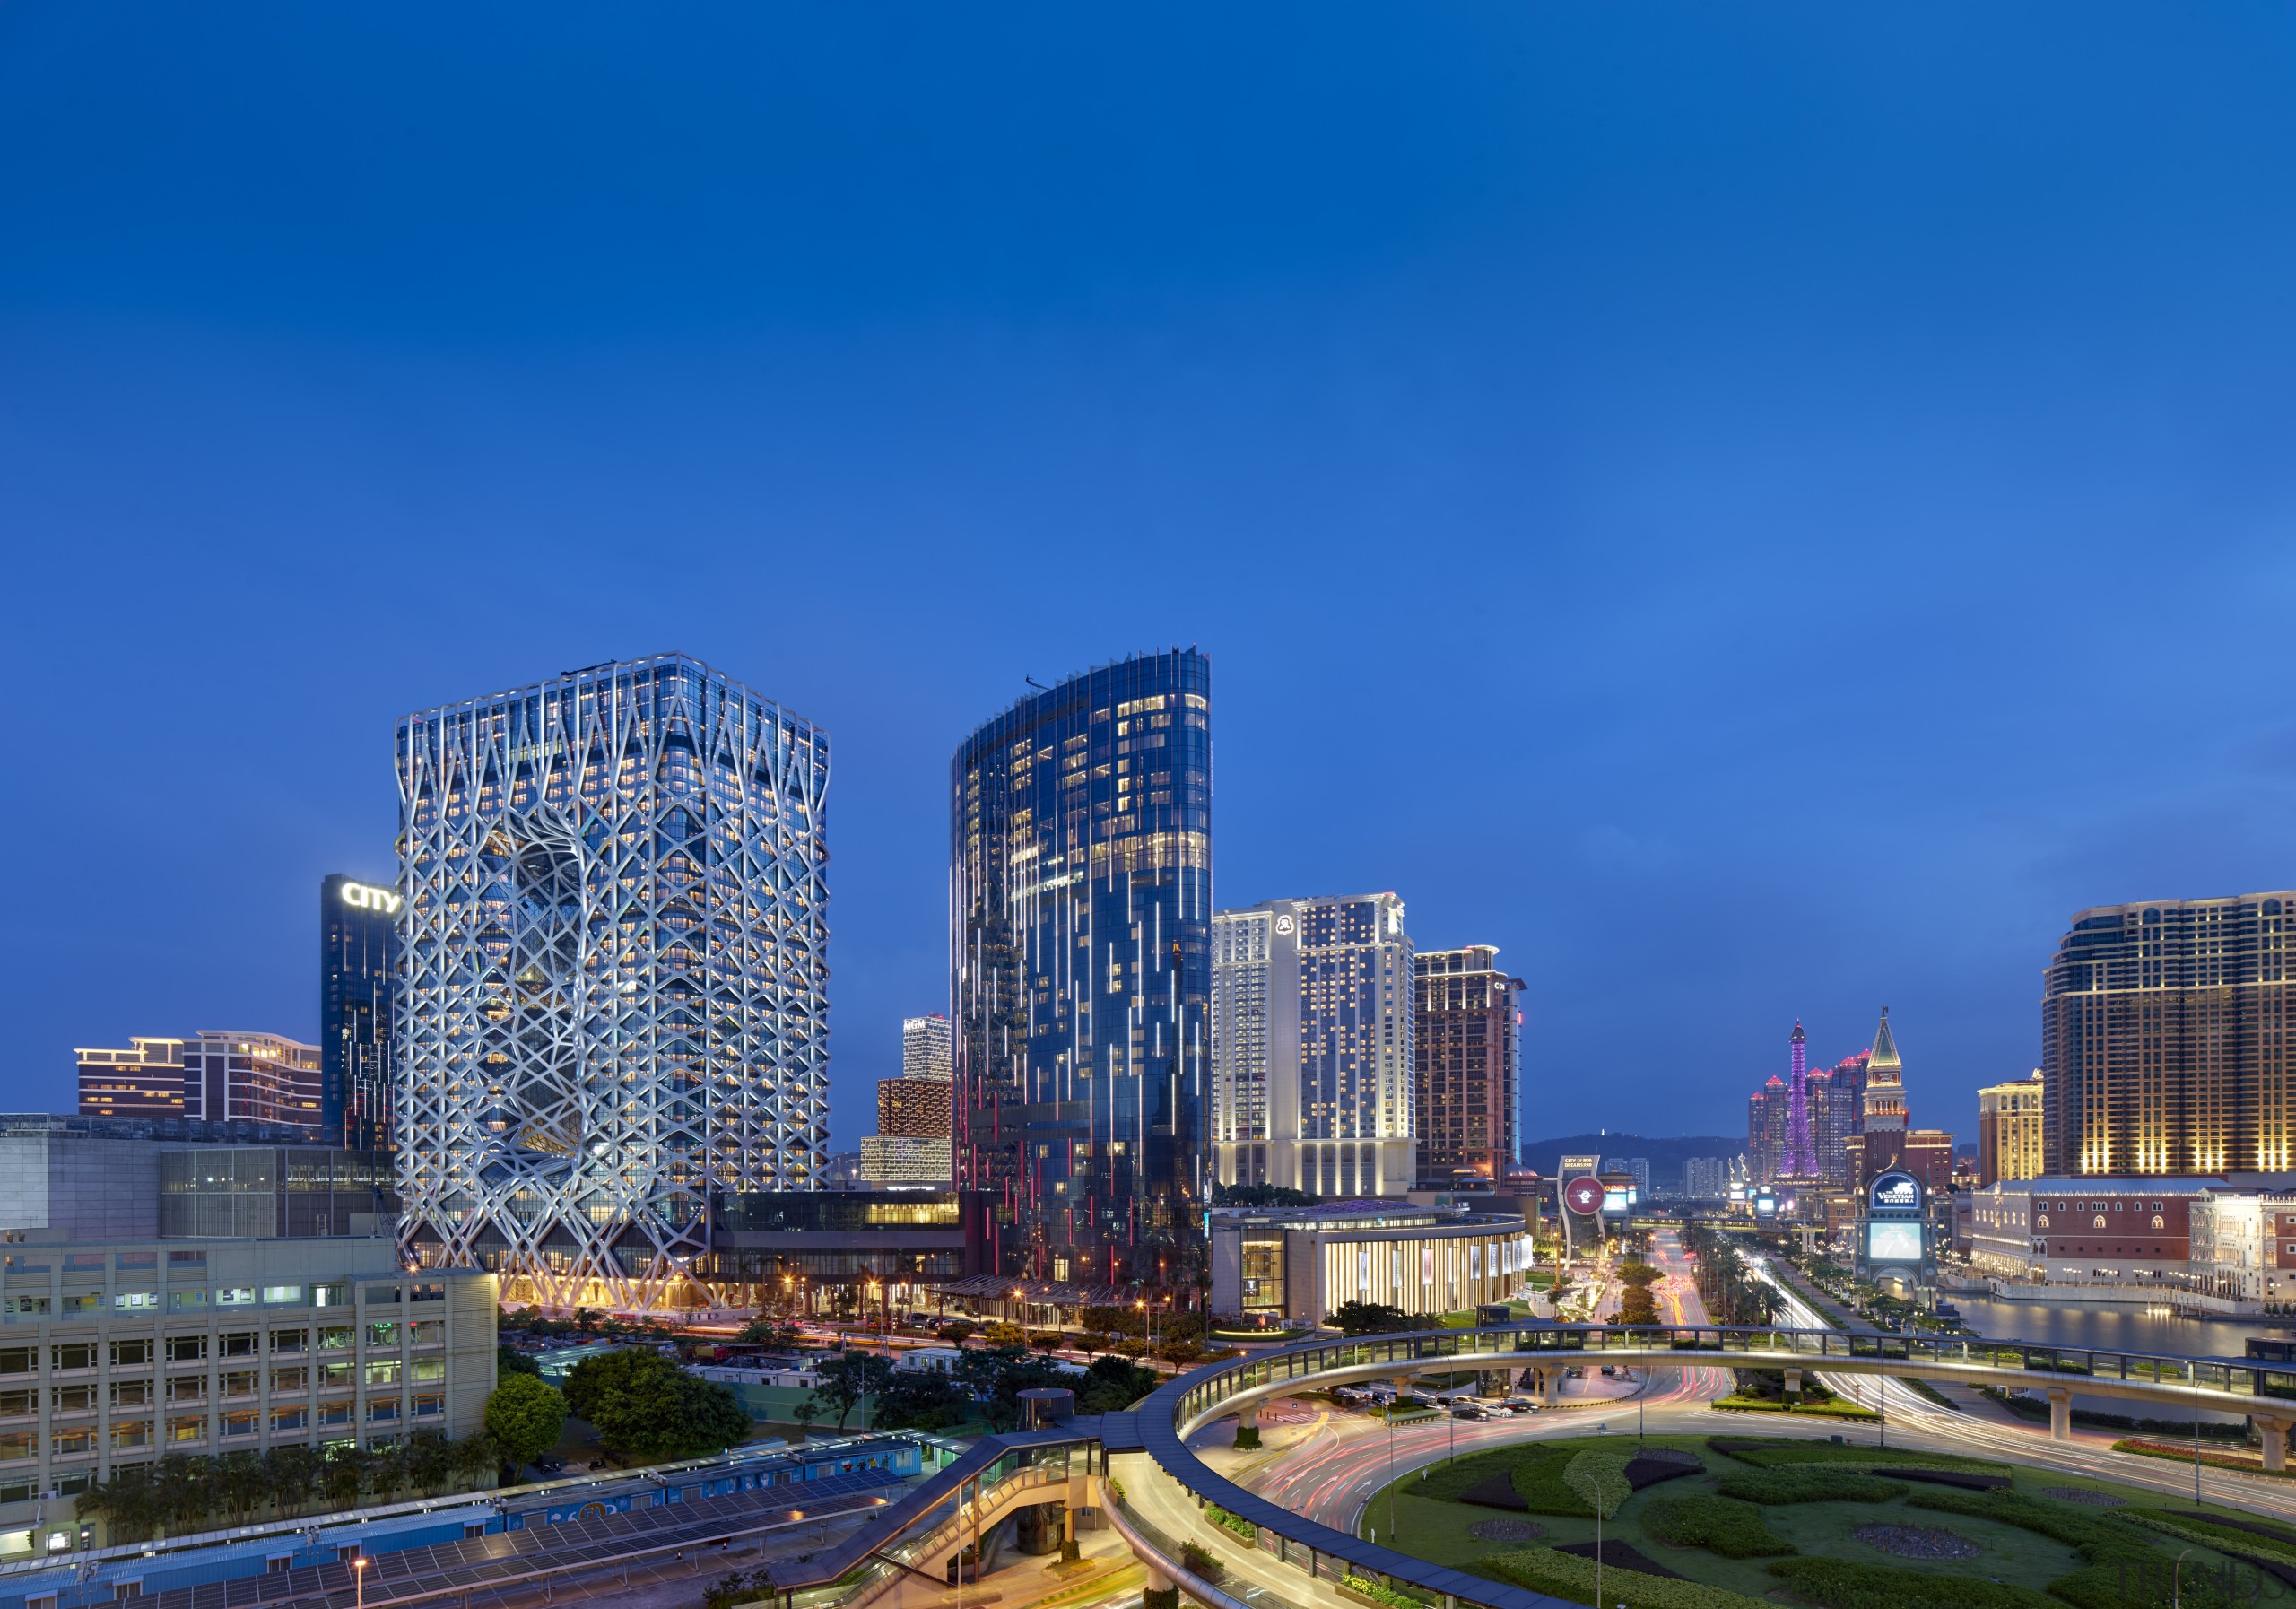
948,649 -> 1213,1285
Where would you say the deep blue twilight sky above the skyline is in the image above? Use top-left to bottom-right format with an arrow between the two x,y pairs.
0,0 -> 2296,1145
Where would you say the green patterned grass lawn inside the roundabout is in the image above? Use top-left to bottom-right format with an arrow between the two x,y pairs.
1366,1437 -> 2268,1597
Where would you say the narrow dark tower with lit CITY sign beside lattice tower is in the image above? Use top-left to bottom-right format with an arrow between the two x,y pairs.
319,872 -> 404,1150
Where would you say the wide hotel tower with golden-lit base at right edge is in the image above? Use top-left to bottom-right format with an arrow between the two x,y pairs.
2041,891 -> 2296,1178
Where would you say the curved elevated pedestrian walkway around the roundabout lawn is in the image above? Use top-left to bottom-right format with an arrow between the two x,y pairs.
776,1325 -> 2296,1609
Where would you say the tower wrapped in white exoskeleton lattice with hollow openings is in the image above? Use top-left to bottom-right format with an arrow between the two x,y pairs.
397,654 -> 829,1309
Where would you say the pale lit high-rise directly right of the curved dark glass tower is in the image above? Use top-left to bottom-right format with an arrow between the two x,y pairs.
1213,893 -> 1419,1196
